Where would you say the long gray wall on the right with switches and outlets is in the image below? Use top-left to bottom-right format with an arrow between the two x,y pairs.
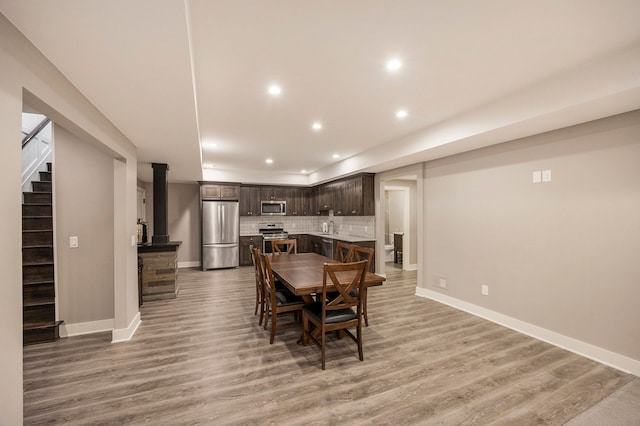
422,111 -> 640,360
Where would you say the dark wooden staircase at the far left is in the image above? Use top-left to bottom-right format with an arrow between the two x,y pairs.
22,163 -> 62,345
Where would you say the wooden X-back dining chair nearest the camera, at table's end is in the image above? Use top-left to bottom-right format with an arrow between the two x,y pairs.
302,260 -> 368,370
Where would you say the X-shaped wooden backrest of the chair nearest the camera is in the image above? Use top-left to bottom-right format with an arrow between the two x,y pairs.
322,260 -> 368,312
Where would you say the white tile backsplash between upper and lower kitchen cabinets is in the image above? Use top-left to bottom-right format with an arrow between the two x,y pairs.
240,215 -> 376,239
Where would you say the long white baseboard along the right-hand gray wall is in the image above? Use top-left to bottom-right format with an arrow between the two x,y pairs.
416,287 -> 640,376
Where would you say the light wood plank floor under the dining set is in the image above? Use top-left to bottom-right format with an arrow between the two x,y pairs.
24,267 -> 633,425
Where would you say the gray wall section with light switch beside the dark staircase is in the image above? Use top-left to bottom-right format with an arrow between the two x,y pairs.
54,125 -> 114,326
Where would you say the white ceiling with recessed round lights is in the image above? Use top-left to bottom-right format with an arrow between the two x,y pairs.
0,0 -> 640,184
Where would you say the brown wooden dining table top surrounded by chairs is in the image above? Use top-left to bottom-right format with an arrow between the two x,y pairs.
269,253 -> 385,303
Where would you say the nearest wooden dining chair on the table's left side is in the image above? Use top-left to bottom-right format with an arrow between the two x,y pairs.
260,254 -> 304,344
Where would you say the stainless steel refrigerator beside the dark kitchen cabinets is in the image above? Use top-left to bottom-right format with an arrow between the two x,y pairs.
202,201 -> 240,270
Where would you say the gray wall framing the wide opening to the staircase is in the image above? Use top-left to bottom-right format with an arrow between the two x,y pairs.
0,14 -> 138,425
